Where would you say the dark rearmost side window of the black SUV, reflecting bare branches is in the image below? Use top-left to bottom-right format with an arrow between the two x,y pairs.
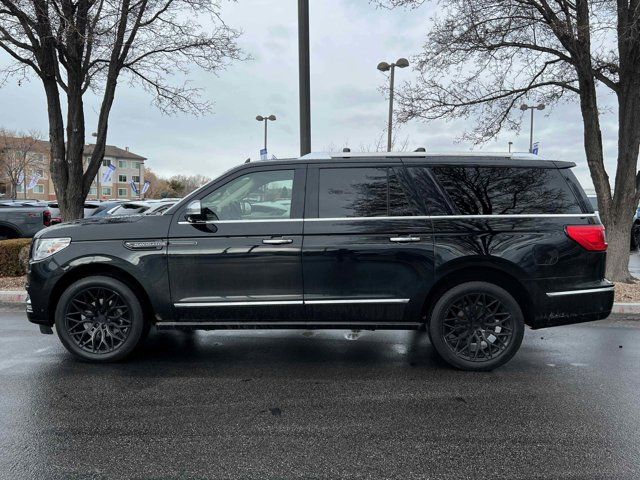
433,167 -> 582,215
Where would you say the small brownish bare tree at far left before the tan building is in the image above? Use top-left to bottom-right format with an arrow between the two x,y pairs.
0,128 -> 46,199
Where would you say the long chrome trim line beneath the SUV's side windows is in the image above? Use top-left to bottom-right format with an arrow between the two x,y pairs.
178,213 -> 598,225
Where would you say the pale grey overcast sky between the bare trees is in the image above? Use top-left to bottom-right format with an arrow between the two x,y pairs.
0,0 -> 617,188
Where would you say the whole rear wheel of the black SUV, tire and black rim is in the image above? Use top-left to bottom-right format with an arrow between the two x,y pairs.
428,282 -> 524,371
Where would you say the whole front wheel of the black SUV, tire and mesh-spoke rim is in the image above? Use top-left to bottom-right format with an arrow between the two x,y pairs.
55,276 -> 149,363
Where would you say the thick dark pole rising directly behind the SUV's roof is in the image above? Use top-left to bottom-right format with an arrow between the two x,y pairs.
298,0 -> 311,156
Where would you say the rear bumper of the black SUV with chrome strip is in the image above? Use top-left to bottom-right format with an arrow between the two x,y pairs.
531,281 -> 614,328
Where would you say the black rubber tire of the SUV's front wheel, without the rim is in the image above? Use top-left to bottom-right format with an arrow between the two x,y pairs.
55,276 -> 145,363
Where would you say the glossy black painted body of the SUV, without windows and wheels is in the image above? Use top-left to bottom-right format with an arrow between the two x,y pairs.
27,156 -> 613,328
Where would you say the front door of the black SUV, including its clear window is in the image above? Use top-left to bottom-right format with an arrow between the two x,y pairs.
168,166 -> 306,324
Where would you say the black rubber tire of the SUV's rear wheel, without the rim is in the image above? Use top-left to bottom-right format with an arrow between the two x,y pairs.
428,282 -> 524,371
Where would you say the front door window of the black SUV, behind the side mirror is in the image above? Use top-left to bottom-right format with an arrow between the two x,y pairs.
201,170 -> 294,220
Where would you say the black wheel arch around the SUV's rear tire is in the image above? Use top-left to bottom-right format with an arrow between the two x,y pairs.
422,260 -> 534,325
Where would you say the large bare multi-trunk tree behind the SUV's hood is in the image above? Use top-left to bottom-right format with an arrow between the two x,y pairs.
0,0 -> 242,220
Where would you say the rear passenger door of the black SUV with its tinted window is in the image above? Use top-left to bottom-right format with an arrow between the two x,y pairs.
303,160 -> 434,324
